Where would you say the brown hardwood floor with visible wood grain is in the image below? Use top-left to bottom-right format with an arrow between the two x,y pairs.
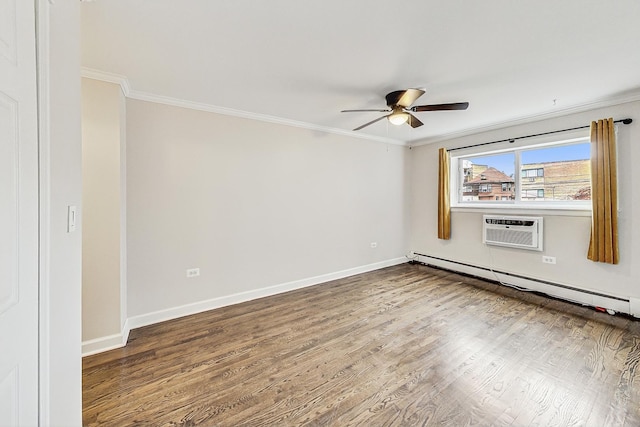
83,264 -> 640,427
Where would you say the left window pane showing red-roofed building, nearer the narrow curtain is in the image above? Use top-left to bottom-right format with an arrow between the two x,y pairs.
461,153 -> 515,202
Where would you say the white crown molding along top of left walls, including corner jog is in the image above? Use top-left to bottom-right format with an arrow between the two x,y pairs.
77,67 -> 407,146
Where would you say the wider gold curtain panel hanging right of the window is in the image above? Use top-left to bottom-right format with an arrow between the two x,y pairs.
587,118 -> 618,264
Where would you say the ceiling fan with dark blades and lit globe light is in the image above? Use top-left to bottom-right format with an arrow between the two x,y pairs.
341,89 -> 469,130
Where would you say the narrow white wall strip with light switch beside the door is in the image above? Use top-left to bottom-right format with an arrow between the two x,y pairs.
38,0 -> 82,427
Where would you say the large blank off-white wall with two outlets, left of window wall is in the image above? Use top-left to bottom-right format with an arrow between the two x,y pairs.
127,99 -> 409,326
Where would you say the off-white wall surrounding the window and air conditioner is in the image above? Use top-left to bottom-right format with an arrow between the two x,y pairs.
410,102 -> 640,304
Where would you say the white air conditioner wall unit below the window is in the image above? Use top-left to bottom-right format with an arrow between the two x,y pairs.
482,215 -> 543,251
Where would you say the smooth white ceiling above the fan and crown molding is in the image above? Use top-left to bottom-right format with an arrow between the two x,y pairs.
82,0 -> 640,142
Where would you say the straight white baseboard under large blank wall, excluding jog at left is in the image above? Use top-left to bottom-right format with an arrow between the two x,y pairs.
128,257 -> 407,338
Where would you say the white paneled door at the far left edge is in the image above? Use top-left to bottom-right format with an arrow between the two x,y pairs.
0,0 -> 38,426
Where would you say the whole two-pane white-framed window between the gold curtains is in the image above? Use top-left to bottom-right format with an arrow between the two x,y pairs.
451,137 -> 591,209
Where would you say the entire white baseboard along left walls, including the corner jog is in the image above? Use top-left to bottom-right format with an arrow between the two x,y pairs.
82,257 -> 407,357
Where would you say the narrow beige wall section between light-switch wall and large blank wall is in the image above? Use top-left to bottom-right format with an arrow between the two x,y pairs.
82,78 -> 124,352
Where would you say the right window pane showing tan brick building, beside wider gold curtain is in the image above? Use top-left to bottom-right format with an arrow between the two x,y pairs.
520,142 -> 591,201
